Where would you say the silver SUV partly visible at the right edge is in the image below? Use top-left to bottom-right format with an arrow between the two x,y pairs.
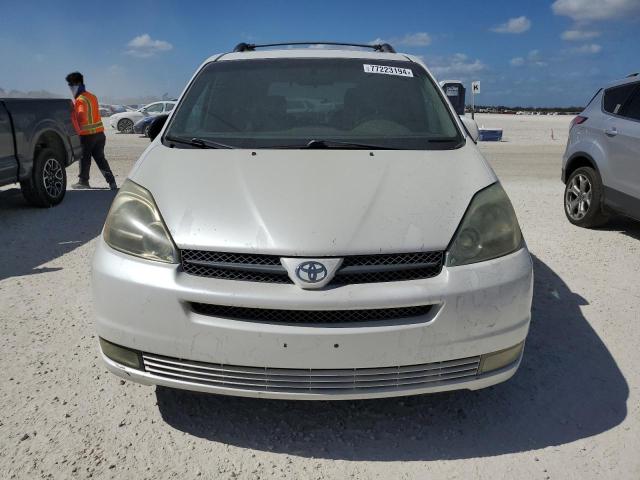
562,74 -> 640,227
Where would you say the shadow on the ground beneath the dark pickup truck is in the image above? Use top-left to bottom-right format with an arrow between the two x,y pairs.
0,189 -> 115,280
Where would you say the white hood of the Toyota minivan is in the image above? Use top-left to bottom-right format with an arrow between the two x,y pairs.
131,142 -> 496,256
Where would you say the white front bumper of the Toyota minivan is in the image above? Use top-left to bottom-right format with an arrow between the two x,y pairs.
93,239 -> 533,399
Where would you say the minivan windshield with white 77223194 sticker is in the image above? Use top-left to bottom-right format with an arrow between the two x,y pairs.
164,58 -> 463,150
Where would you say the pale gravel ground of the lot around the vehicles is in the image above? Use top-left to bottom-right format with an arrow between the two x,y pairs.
0,115 -> 640,480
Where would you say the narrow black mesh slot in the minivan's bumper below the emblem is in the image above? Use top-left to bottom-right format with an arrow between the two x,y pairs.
190,303 -> 432,325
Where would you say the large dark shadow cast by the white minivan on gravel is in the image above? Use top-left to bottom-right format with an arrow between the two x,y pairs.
156,258 -> 629,460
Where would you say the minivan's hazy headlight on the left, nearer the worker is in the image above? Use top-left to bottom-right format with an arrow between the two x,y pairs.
103,180 -> 178,263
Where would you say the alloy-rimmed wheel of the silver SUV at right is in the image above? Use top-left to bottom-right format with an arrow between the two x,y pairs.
564,167 -> 607,228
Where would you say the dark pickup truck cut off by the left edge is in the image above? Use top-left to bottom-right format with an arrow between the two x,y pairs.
0,98 -> 82,207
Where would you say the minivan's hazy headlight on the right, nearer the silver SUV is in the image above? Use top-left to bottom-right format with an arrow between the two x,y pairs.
447,183 -> 522,267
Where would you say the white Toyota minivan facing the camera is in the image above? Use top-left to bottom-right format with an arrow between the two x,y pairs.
93,44 -> 533,400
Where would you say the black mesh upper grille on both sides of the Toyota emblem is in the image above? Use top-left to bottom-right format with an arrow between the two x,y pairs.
182,250 -> 444,286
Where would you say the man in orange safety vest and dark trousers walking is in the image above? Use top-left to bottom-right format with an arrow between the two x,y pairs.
66,72 -> 118,190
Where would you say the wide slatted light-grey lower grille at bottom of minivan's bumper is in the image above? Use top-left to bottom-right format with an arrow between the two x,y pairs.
142,353 -> 480,394
